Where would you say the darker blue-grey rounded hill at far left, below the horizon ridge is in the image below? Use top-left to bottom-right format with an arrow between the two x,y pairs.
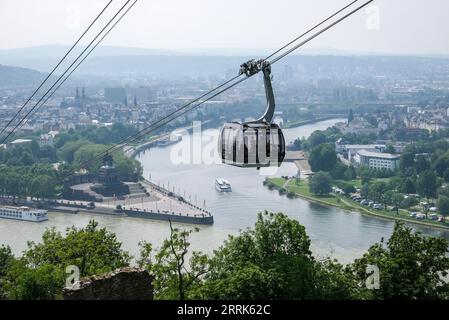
0,64 -> 47,88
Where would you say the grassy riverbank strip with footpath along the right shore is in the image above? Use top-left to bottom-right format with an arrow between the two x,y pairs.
264,178 -> 449,230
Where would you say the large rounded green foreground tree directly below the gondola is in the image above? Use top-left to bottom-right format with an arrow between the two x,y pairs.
195,212 -> 349,299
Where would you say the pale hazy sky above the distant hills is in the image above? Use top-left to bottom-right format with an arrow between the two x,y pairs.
0,0 -> 449,54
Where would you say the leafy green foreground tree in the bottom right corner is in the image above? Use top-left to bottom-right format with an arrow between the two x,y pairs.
350,222 -> 449,300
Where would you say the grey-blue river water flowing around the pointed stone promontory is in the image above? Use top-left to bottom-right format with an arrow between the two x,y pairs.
0,120 -> 449,263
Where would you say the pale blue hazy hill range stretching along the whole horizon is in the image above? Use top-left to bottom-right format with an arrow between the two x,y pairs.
0,45 -> 449,80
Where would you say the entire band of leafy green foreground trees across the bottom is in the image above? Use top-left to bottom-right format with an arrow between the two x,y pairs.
0,212 -> 449,300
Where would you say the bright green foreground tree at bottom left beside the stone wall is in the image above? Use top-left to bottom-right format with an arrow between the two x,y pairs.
0,221 -> 130,300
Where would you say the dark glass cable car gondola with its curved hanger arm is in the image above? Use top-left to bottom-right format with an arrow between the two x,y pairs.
219,60 -> 285,169
